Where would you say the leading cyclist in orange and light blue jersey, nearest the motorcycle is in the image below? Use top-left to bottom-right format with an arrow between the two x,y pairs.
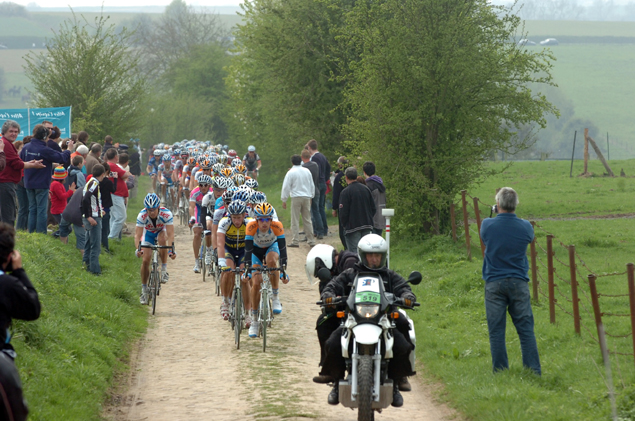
245,203 -> 289,338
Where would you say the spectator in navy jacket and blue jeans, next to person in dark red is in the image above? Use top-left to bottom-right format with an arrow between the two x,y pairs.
20,124 -> 74,234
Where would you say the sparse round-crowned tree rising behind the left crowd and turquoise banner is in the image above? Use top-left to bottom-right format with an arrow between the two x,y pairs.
25,14 -> 146,139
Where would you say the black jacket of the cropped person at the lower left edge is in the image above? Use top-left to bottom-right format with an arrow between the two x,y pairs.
0,268 -> 41,348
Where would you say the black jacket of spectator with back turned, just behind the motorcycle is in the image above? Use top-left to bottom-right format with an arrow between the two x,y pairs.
340,181 -> 377,234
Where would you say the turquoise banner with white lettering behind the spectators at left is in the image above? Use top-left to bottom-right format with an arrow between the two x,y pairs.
0,107 -> 71,140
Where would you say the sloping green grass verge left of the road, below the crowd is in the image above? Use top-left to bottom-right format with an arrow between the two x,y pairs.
12,218 -> 147,420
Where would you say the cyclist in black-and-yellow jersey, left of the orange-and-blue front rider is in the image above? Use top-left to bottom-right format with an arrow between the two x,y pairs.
216,200 -> 251,327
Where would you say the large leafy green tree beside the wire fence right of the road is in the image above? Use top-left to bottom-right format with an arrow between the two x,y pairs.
346,0 -> 557,232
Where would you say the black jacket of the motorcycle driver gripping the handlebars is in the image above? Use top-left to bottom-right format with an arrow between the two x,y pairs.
322,262 -> 417,301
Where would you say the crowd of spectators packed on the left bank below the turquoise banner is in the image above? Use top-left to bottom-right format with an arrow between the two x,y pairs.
0,120 -> 141,274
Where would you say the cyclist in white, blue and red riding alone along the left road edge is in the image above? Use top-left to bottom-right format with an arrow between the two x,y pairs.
135,193 -> 176,305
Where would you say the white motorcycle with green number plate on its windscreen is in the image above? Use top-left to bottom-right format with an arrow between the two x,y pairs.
317,272 -> 421,421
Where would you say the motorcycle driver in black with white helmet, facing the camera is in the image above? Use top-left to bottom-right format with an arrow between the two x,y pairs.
322,234 -> 417,407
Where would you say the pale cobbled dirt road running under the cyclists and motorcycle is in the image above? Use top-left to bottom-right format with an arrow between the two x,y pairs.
105,226 -> 454,421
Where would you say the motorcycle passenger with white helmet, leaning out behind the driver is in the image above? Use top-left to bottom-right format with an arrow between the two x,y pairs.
305,244 -> 359,383
